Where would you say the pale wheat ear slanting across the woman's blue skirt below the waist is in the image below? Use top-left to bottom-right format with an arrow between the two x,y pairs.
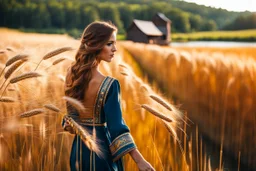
64,116 -> 103,156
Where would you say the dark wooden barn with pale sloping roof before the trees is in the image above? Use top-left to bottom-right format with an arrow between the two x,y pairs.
126,13 -> 171,45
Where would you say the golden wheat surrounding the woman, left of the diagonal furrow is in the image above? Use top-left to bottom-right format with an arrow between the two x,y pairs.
0,29 -> 215,171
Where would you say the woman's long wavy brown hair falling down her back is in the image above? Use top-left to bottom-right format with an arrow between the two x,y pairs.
65,21 -> 117,101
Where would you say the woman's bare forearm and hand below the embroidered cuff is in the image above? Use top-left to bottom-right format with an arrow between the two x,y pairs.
129,149 -> 155,171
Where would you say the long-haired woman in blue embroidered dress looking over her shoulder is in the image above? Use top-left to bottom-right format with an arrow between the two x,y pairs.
63,22 -> 154,171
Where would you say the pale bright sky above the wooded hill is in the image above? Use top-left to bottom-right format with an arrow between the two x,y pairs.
184,0 -> 256,12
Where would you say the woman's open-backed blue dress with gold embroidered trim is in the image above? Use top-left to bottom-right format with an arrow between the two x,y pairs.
62,76 -> 136,171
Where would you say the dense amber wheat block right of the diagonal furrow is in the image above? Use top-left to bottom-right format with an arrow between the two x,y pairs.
122,41 -> 256,168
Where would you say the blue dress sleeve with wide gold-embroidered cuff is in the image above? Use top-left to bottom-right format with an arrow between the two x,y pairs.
104,80 -> 136,161
